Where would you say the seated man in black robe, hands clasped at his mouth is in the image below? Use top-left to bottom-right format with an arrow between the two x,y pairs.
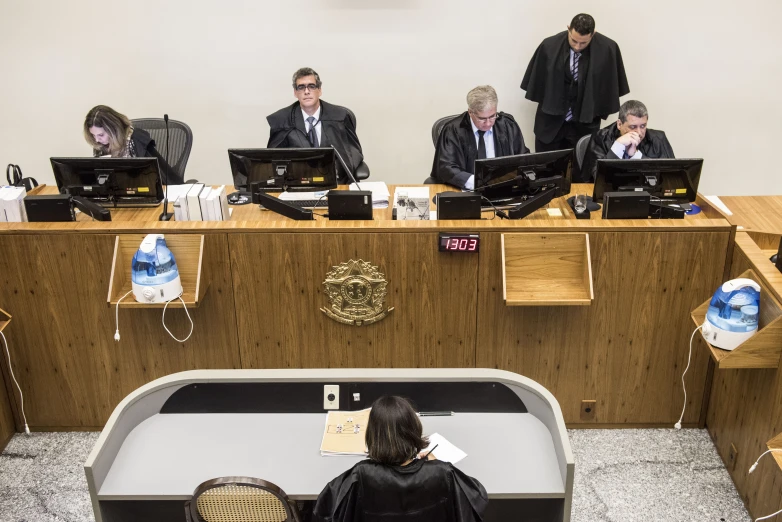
573,100 -> 675,183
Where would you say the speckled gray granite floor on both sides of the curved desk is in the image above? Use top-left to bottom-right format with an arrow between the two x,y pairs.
0,430 -> 751,522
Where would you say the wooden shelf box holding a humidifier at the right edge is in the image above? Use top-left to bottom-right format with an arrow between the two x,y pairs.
690,269 -> 782,370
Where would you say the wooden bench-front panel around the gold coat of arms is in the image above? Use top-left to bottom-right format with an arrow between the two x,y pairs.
229,232 -> 483,368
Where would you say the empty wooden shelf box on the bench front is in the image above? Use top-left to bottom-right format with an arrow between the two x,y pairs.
502,233 -> 595,306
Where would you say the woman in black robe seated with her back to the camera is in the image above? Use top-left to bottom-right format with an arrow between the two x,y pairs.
314,396 -> 488,522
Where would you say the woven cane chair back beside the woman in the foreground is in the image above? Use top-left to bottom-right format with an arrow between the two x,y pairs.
185,477 -> 301,522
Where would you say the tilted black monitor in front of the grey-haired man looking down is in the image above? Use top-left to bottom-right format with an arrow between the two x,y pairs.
475,149 -> 573,199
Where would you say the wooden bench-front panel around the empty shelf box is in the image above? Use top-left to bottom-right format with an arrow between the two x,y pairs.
476,230 -> 730,425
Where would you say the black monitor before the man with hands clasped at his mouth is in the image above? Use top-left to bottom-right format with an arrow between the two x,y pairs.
592,158 -> 703,202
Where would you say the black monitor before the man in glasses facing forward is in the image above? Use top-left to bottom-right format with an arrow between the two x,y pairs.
228,147 -> 337,192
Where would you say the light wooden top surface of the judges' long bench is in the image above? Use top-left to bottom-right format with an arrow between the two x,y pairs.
0,184 -> 728,234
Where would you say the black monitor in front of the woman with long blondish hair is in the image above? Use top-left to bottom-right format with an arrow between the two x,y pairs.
50,157 -> 164,207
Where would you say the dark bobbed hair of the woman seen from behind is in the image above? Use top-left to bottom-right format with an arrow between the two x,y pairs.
366,395 -> 429,466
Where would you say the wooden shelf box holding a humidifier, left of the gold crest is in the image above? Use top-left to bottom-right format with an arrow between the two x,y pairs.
108,234 -> 209,308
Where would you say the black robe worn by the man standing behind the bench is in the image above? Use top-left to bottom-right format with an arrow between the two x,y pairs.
521,31 -> 630,143
